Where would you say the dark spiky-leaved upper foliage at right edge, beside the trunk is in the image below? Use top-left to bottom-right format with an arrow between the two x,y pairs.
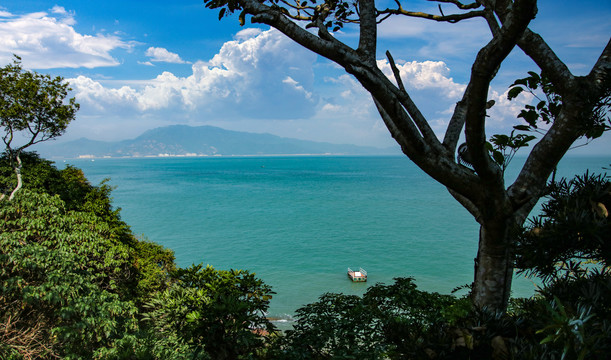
516,172 -> 611,281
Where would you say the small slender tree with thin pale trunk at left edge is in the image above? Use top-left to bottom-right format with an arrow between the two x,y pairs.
0,55 -> 79,200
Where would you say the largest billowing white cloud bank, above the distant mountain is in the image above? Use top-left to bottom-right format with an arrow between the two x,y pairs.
69,30 -> 317,119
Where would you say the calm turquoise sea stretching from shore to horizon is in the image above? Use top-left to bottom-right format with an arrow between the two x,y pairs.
57,156 -> 611,319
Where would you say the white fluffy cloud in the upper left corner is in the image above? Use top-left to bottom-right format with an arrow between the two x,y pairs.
0,6 -> 132,69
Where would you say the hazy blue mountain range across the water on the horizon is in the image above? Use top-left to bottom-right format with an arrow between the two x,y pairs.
35,125 -> 398,158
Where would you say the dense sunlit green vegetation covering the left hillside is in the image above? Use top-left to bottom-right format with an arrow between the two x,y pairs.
0,153 -> 272,359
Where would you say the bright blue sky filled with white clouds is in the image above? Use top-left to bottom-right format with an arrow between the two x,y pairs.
0,0 -> 611,154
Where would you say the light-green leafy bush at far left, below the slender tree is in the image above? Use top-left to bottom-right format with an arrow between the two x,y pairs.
0,190 -> 137,359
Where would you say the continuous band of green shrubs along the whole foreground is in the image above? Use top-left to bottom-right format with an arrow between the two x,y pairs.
0,153 -> 611,359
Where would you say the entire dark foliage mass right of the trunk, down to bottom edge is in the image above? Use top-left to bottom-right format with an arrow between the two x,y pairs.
516,172 -> 611,359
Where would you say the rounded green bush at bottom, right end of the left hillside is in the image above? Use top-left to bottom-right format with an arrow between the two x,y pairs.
146,265 -> 274,359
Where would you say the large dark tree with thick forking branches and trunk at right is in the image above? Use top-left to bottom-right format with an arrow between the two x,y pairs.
204,0 -> 611,311
